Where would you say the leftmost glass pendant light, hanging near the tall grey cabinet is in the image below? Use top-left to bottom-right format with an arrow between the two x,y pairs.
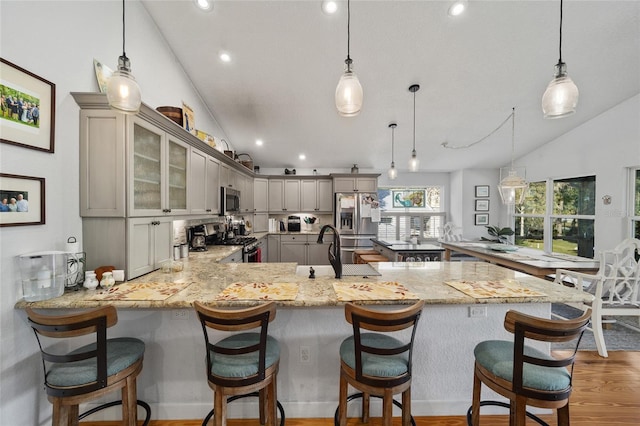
107,0 -> 142,114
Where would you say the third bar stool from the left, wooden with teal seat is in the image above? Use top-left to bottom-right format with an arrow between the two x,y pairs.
334,300 -> 424,426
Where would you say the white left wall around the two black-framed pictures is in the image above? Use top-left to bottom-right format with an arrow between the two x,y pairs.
0,0 -> 226,425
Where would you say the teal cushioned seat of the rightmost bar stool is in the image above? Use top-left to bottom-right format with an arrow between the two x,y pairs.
473,340 -> 571,391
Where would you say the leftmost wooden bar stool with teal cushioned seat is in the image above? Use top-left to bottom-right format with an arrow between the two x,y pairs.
26,306 -> 151,426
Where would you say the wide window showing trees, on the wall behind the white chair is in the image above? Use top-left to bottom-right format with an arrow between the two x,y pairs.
514,176 -> 596,258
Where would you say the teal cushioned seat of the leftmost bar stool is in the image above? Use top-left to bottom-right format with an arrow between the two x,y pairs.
47,337 -> 144,387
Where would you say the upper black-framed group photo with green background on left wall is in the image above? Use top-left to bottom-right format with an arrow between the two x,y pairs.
0,58 -> 56,153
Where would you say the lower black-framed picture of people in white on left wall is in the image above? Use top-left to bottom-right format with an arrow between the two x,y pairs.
0,173 -> 45,226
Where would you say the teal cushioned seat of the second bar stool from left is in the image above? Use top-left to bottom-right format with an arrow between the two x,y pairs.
211,333 -> 280,377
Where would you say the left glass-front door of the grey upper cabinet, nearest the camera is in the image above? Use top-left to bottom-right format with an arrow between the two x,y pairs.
129,118 -> 165,216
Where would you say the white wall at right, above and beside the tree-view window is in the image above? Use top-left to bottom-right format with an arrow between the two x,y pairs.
518,95 -> 640,253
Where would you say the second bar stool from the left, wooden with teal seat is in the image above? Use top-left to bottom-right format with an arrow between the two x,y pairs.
193,302 -> 285,426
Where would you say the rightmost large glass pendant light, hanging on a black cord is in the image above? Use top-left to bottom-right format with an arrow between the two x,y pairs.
542,0 -> 579,118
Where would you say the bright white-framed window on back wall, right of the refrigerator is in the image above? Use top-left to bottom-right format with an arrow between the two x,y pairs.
378,186 -> 446,241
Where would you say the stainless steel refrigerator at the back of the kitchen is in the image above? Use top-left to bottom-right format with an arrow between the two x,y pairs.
334,192 -> 379,263
